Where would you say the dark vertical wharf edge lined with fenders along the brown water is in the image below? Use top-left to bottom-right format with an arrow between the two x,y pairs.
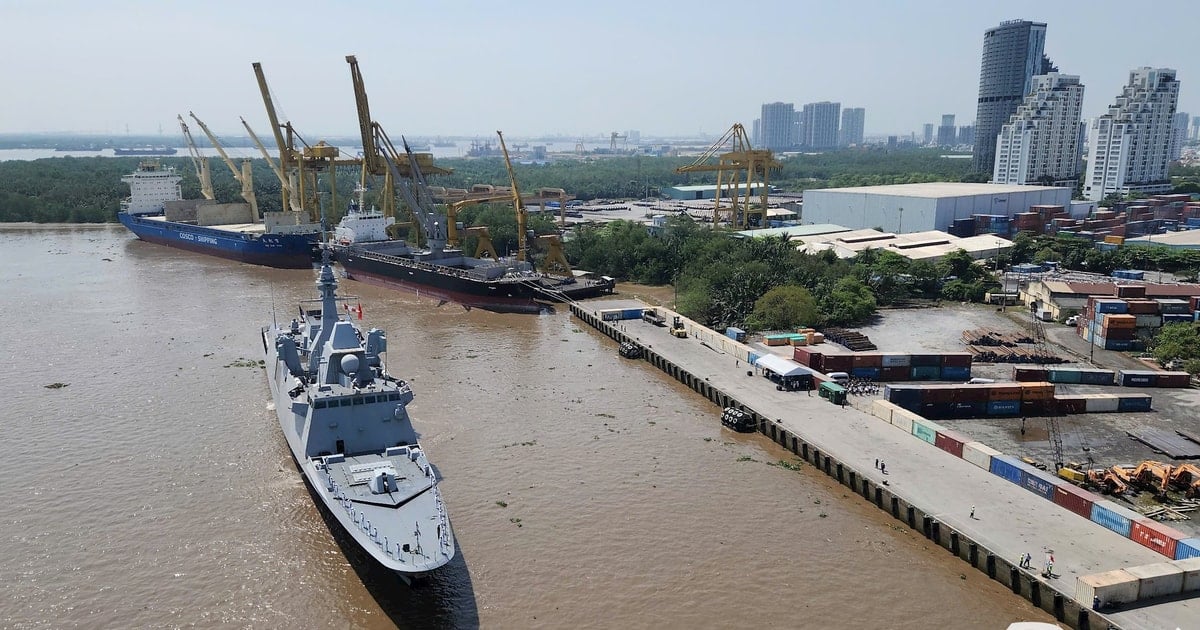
570,302 -> 1120,630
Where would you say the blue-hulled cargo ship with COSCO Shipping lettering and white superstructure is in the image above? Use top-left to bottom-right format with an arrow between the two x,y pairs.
116,162 -> 322,269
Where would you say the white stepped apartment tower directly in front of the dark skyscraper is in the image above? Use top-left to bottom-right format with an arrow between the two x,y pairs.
991,72 -> 1084,188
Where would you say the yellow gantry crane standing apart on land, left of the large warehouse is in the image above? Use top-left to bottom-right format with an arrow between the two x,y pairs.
676,122 -> 781,229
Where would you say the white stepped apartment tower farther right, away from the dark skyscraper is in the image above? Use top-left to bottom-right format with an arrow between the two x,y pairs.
1084,67 -> 1180,202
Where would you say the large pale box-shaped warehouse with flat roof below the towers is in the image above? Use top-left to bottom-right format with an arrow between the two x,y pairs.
804,181 -> 1072,234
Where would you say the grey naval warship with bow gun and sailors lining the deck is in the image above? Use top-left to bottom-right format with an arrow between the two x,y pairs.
263,253 -> 455,581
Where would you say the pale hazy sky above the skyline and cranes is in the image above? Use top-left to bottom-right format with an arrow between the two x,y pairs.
0,0 -> 1200,138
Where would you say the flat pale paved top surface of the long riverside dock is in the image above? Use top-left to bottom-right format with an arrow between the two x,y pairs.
600,302 -> 1200,630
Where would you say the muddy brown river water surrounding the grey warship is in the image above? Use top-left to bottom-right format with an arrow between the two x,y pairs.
0,227 -> 1046,629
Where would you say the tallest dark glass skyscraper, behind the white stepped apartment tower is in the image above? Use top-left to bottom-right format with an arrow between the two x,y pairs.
971,19 -> 1057,173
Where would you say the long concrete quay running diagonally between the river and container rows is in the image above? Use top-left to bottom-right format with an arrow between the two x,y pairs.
571,300 -> 1200,630
